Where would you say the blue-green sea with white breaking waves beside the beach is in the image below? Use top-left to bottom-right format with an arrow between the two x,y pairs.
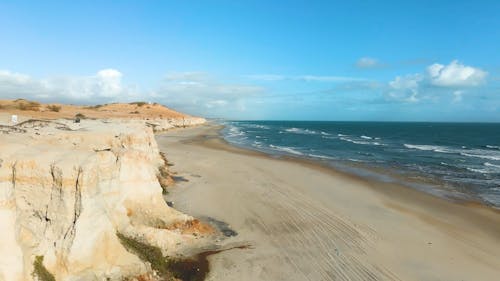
223,121 -> 500,208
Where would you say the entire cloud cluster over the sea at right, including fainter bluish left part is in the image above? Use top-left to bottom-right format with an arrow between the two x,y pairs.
386,60 -> 488,103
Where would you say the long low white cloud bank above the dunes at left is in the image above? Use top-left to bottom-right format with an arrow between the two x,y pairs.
0,69 -> 263,116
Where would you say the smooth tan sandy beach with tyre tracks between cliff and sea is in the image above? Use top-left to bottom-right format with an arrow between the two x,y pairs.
156,125 -> 500,280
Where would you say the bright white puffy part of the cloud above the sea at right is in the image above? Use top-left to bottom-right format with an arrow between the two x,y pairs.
427,60 -> 488,87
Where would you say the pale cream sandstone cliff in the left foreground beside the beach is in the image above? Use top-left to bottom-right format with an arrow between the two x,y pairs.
0,117 -> 207,281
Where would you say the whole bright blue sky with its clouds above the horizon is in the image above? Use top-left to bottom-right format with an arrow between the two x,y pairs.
0,0 -> 500,122
